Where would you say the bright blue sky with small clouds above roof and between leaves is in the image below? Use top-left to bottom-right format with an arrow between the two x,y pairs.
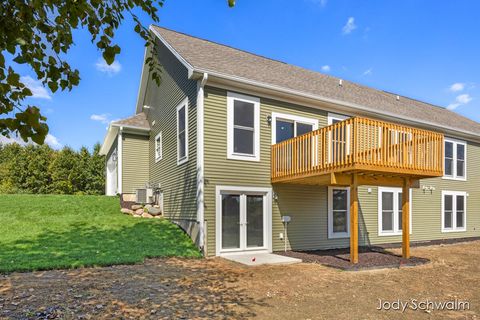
7,0 -> 480,149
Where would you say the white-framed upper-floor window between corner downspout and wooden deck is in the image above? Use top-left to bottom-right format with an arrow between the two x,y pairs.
227,92 -> 260,161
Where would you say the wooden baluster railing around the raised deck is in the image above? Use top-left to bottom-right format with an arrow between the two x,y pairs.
271,117 -> 444,182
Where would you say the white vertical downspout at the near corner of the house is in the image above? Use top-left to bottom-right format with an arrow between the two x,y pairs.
197,73 -> 208,255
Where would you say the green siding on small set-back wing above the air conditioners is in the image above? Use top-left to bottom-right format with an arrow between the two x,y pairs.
122,133 -> 149,193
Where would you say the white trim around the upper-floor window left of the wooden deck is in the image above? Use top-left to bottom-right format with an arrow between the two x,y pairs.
227,92 -> 260,161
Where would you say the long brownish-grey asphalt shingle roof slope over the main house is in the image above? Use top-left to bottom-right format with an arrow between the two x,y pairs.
152,26 -> 480,136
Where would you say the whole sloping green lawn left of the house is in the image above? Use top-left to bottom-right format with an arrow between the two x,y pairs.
0,195 -> 200,272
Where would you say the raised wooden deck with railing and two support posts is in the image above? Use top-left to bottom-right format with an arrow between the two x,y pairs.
271,117 -> 444,263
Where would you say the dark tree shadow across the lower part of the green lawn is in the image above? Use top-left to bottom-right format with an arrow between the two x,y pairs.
0,217 -> 200,272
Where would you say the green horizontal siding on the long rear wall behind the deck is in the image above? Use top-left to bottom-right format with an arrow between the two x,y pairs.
205,87 -> 480,255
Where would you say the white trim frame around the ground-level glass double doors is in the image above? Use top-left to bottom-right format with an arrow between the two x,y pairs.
215,186 -> 272,256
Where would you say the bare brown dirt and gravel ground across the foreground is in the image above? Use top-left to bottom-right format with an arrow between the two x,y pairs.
0,241 -> 480,319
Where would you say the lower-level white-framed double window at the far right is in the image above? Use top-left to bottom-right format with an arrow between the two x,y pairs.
442,191 -> 467,232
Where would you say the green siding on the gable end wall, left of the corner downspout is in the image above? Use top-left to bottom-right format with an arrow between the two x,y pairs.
143,38 -> 197,226
